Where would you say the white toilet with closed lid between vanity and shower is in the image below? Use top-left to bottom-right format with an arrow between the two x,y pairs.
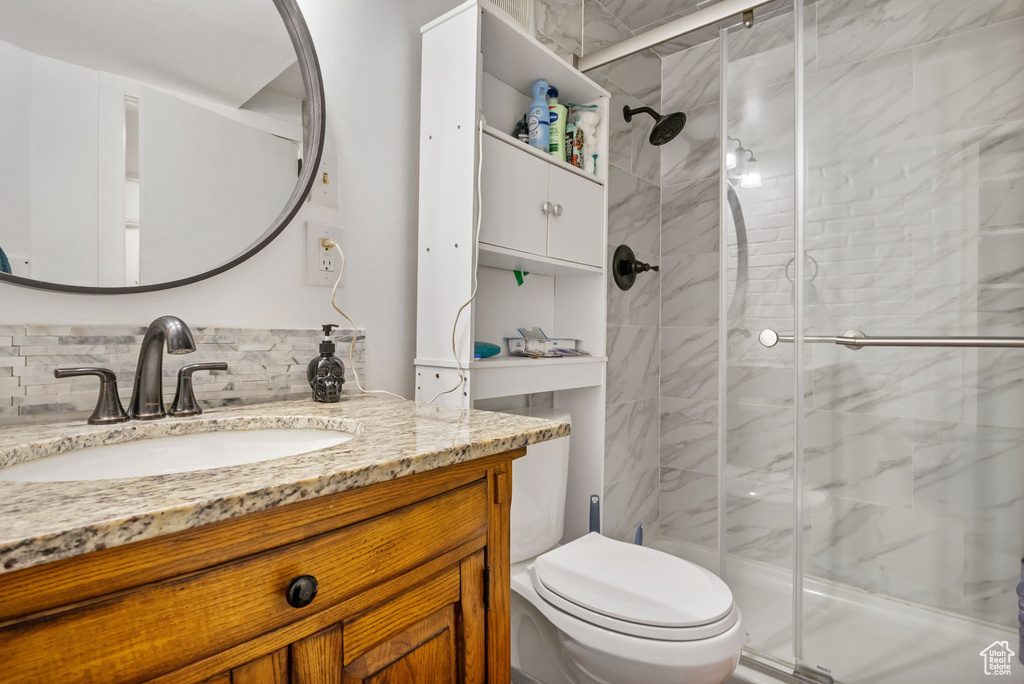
507,409 -> 744,684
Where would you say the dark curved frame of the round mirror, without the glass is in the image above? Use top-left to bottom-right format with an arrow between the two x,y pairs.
0,0 -> 326,295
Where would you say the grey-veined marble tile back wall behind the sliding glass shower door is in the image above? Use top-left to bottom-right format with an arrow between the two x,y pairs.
659,0 -> 1024,626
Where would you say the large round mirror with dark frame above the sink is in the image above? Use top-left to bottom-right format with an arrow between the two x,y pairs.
0,0 -> 324,294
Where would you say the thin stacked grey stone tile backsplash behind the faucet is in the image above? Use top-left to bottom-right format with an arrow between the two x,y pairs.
0,325 -> 366,424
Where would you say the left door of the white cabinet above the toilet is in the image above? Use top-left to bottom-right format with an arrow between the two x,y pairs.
480,135 -> 549,254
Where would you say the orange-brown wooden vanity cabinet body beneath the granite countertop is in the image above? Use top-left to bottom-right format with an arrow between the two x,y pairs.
0,450 -> 516,684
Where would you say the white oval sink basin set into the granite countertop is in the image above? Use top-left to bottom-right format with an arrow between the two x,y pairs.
0,428 -> 355,482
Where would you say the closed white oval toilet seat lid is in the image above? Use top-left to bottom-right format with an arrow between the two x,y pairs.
534,532 -> 733,628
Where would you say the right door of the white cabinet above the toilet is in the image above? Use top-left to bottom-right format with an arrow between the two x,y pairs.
548,168 -> 604,266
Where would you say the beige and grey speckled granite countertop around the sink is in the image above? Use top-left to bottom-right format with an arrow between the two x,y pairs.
0,396 -> 569,572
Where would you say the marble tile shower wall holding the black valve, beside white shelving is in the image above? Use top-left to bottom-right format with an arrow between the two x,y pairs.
537,0 -> 672,541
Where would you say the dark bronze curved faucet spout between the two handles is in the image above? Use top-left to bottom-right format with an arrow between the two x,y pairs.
128,315 -> 196,421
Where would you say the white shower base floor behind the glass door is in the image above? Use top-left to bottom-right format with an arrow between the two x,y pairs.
650,537 -> 1011,684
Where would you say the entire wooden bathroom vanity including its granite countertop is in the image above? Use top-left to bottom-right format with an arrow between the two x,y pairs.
0,397 -> 568,684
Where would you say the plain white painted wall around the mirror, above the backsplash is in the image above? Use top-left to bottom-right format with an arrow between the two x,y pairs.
0,0 -> 459,396
